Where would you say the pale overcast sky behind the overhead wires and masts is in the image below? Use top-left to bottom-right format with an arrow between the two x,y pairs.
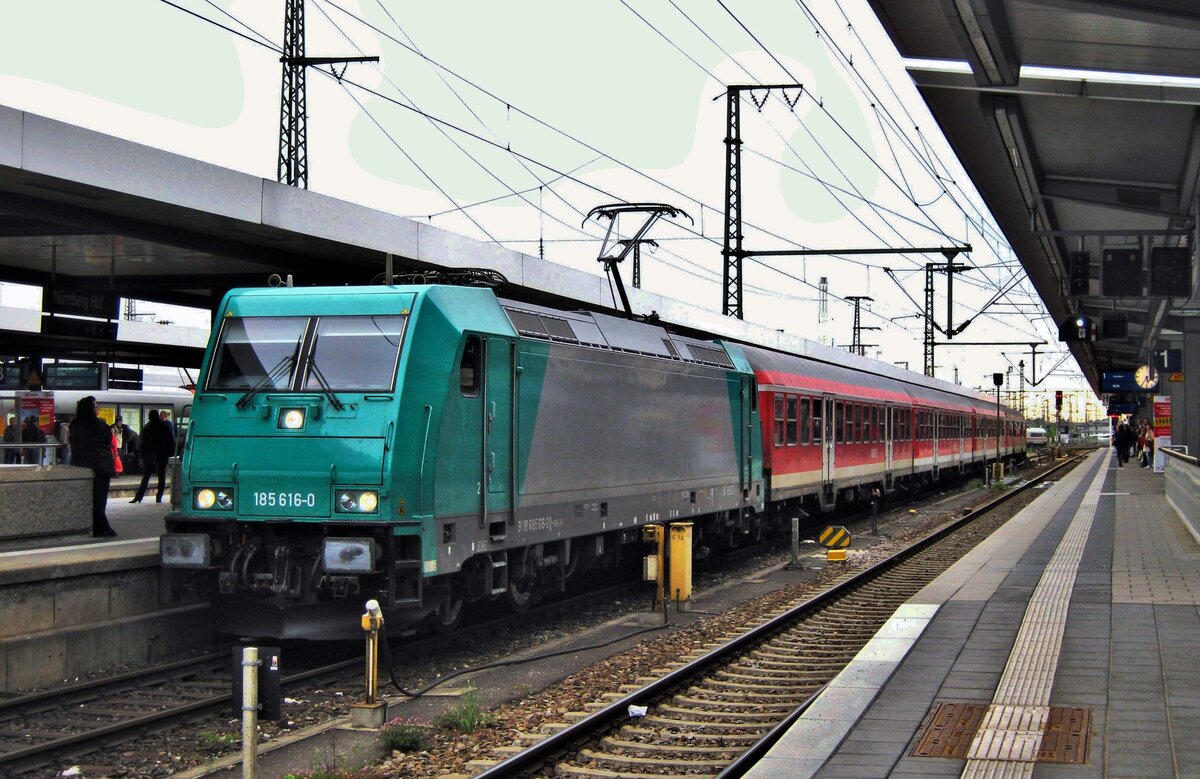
0,0 -> 1099,410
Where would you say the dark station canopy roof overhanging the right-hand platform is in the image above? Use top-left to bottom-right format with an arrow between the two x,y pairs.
869,0 -> 1200,391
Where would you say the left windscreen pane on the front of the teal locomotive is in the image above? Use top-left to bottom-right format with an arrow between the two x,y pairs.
208,317 -> 308,390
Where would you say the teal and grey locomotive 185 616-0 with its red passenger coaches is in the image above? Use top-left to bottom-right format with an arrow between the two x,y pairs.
161,284 -> 1025,639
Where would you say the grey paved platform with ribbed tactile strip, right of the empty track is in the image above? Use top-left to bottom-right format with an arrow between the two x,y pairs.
746,449 -> 1200,779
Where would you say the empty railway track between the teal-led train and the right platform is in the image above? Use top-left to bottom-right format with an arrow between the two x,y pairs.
476,460 -> 1075,779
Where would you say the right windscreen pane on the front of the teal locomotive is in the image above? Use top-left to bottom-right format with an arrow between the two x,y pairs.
304,316 -> 408,393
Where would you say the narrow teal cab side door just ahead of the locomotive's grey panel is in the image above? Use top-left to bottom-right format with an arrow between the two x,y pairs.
480,337 -> 516,538
